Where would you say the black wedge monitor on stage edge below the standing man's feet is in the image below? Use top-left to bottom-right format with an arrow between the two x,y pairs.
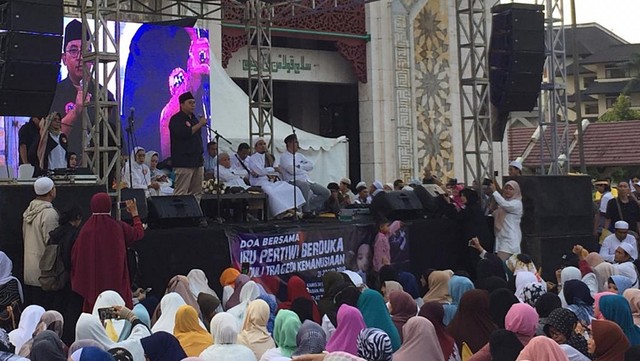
148,196 -> 202,228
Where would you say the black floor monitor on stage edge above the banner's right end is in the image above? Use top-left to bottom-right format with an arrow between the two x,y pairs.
370,191 -> 424,220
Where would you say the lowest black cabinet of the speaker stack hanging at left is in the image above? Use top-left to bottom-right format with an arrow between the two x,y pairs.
0,89 -> 55,117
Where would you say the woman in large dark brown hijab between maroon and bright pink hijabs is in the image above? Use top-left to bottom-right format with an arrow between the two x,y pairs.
447,290 -> 496,353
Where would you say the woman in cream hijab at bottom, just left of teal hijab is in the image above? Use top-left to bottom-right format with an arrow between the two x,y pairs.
238,300 -> 276,360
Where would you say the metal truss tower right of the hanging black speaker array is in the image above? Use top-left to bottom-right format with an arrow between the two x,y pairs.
536,0 -> 568,175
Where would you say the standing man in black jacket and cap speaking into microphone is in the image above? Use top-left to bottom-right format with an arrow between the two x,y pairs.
169,92 -> 207,202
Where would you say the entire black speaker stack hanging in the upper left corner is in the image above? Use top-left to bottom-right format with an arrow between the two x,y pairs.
0,0 -> 63,116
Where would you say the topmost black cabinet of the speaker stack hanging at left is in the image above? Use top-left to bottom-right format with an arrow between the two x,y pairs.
0,0 -> 64,34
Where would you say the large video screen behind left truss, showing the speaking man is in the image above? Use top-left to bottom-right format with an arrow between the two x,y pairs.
0,18 -> 210,169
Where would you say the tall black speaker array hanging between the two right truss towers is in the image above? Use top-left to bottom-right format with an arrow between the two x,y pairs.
489,3 -> 546,141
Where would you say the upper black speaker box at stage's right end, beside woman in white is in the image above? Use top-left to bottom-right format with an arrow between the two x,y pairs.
505,176 -> 593,237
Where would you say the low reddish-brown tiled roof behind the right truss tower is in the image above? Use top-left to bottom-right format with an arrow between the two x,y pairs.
508,120 -> 640,168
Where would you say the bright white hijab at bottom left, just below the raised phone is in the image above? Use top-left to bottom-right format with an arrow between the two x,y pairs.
76,313 -> 149,361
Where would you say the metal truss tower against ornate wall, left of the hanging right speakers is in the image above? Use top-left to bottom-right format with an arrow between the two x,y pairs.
456,0 -> 493,184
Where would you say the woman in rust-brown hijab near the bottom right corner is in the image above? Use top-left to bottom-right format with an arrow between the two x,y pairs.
589,320 -> 629,361
